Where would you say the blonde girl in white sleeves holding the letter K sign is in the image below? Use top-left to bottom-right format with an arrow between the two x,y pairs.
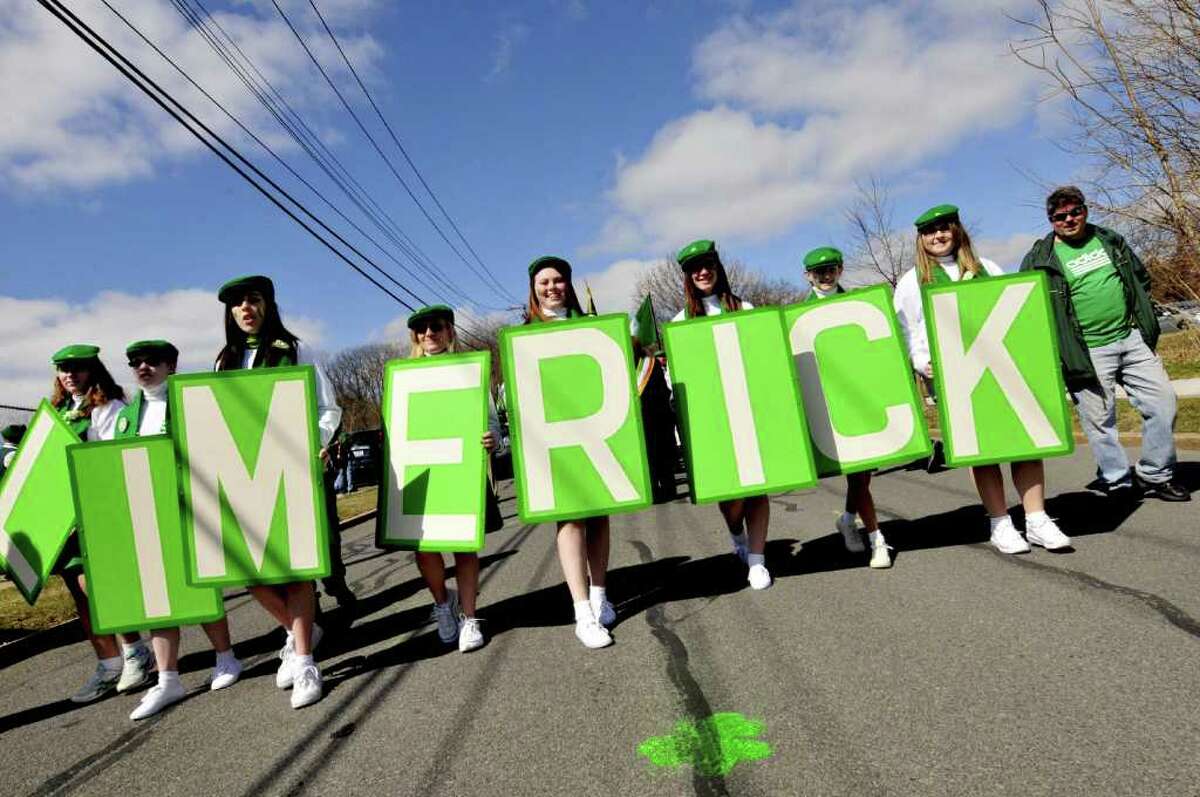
893,205 -> 1070,553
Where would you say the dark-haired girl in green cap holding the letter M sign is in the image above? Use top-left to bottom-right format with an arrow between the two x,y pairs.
216,276 -> 342,708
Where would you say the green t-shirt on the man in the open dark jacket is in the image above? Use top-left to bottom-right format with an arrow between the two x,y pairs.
1054,235 -> 1130,348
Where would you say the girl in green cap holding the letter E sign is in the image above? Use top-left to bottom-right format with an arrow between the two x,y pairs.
408,305 -> 500,653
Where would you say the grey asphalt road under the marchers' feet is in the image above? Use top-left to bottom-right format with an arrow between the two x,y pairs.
0,448 -> 1200,797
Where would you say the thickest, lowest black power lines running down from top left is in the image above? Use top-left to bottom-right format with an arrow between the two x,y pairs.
38,0 -> 496,343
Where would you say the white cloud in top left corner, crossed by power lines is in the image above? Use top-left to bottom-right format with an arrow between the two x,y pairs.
0,0 -> 382,190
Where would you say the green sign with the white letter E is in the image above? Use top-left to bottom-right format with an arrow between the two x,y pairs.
376,352 -> 492,551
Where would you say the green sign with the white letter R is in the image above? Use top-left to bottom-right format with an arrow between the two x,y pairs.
500,314 -> 650,523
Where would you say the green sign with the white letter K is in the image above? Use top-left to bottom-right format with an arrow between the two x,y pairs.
924,272 -> 1075,467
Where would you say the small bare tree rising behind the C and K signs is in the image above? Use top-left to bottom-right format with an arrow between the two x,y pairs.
846,176 -> 913,288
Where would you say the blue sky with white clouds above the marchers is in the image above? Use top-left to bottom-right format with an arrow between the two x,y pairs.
0,0 -> 1082,402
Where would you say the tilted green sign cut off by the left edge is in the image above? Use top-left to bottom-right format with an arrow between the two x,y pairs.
0,401 -> 79,605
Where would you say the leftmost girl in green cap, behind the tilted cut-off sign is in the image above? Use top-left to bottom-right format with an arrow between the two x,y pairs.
50,343 -> 151,703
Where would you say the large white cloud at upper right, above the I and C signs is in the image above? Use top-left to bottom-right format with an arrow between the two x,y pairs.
589,0 -> 1037,252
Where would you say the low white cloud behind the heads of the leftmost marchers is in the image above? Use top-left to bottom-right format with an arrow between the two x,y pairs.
0,289 -> 324,407
